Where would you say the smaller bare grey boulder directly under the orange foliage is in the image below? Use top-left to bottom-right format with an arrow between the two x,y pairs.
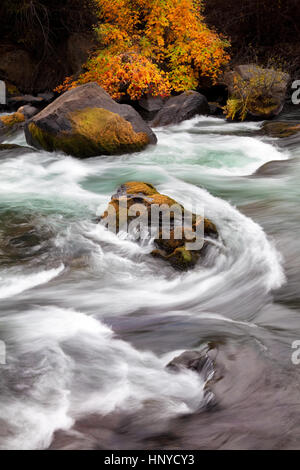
151,90 -> 209,127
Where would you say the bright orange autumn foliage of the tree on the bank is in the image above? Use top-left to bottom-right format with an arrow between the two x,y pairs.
57,0 -> 229,99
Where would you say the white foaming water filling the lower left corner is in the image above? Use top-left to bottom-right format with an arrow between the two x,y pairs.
0,307 -> 204,449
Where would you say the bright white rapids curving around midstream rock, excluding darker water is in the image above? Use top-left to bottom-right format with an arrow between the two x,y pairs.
0,117 -> 290,449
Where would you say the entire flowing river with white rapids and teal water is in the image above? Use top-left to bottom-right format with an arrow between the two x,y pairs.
0,115 -> 300,449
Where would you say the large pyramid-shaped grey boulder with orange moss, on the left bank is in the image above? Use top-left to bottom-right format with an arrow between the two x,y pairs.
25,83 -> 157,158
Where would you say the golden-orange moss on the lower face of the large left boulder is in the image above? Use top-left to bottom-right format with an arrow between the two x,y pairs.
28,108 -> 149,158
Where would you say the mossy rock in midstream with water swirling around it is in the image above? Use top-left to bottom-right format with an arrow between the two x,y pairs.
100,182 -> 218,271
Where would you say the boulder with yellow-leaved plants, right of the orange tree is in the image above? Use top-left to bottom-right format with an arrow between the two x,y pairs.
224,64 -> 290,120
